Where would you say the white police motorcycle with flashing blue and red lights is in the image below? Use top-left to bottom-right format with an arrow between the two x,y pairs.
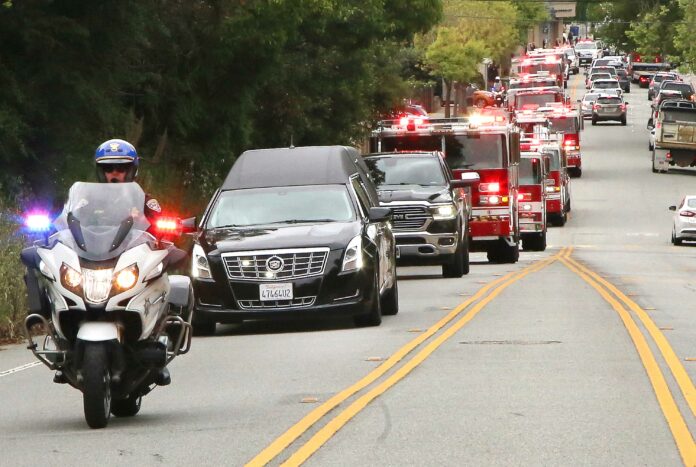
21,182 -> 193,428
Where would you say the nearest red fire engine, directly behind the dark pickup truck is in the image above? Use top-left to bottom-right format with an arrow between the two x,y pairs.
370,111 -> 520,263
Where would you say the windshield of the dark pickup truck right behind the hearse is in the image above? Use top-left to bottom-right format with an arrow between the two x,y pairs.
365,155 -> 447,187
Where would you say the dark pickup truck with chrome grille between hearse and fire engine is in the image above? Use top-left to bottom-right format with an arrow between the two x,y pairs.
358,152 -> 474,277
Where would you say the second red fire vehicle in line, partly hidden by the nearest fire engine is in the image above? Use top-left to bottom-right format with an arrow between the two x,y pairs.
517,152 -> 551,251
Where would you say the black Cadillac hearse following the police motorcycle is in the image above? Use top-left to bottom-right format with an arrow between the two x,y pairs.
192,146 -> 398,334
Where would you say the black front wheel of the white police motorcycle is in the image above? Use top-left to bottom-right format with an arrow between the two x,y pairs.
82,342 -> 111,428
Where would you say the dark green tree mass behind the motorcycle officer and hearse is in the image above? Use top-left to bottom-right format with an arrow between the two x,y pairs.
0,0 -> 442,336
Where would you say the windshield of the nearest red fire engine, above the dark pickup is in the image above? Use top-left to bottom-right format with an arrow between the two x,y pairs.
445,133 -> 508,170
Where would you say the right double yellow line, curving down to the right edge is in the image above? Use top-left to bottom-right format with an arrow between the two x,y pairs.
560,255 -> 696,466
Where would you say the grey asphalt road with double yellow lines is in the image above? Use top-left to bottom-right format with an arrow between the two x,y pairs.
0,75 -> 696,466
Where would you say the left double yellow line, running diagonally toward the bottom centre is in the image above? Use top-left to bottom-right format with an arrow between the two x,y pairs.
247,248 -> 571,466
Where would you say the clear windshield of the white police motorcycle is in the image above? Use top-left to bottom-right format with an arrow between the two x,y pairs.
53,182 -> 152,261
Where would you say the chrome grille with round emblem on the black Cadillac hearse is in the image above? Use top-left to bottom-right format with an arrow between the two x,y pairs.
222,248 -> 329,281
